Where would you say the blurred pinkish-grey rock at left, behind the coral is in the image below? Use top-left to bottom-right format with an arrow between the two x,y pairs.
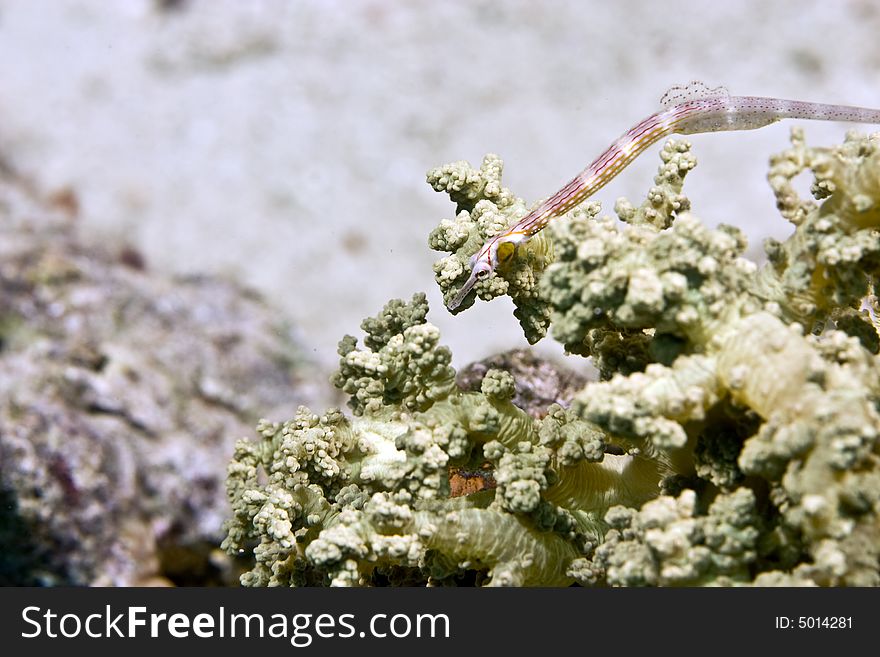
0,170 -> 330,586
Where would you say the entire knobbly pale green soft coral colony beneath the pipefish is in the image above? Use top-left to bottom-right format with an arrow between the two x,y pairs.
224,131 -> 880,586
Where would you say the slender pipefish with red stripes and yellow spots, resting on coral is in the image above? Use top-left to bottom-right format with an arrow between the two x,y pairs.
448,81 -> 880,310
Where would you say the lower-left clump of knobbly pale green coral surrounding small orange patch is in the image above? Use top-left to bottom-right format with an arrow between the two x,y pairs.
224,295 -> 667,585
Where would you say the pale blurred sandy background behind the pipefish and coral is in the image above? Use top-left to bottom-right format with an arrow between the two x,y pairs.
0,0 -> 880,382
